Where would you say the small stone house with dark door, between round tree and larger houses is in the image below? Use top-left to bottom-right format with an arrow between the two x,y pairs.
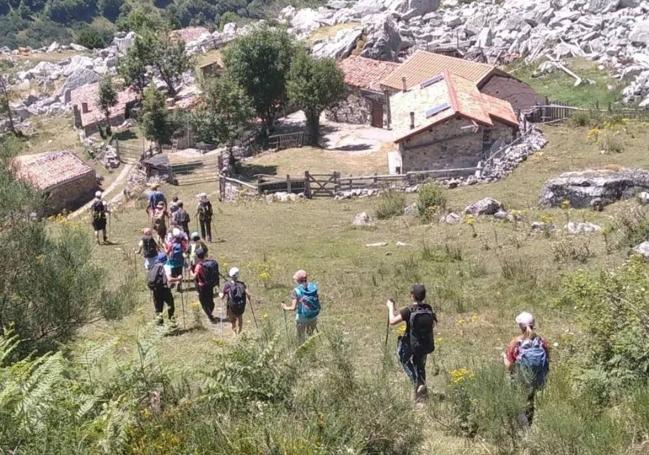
325,56 -> 399,128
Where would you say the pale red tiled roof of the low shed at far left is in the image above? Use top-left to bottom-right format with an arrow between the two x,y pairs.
12,150 -> 95,191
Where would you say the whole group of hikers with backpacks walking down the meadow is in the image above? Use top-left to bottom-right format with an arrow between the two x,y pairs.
92,186 -> 549,416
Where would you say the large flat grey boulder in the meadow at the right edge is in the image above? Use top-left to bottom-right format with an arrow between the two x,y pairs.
539,169 -> 649,208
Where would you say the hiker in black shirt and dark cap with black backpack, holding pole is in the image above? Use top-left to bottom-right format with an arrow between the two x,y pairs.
386,284 -> 437,402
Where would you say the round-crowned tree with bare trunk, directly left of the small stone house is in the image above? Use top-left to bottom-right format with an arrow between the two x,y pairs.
286,49 -> 346,146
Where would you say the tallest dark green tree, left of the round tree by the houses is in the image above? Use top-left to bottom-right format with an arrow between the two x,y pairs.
223,27 -> 295,137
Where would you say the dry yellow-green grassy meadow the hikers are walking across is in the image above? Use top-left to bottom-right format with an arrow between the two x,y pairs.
62,119 -> 649,455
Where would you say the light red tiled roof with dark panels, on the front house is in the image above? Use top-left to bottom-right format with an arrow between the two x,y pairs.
391,71 -> 518,142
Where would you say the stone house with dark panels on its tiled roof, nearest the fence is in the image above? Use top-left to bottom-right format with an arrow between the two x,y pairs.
388,71 -> 518,174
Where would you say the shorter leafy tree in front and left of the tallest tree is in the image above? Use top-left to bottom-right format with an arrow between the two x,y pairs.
192,76 -> 255,169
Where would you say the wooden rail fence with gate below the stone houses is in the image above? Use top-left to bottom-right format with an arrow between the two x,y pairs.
256,167 -> 479,198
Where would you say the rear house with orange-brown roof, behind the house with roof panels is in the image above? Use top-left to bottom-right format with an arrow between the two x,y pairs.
380,50 -> 545,117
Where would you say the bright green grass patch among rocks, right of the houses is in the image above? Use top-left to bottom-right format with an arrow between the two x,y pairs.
509,58 -> 623,109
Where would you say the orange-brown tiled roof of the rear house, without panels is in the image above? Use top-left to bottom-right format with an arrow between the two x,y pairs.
381,50 -> 507,90
